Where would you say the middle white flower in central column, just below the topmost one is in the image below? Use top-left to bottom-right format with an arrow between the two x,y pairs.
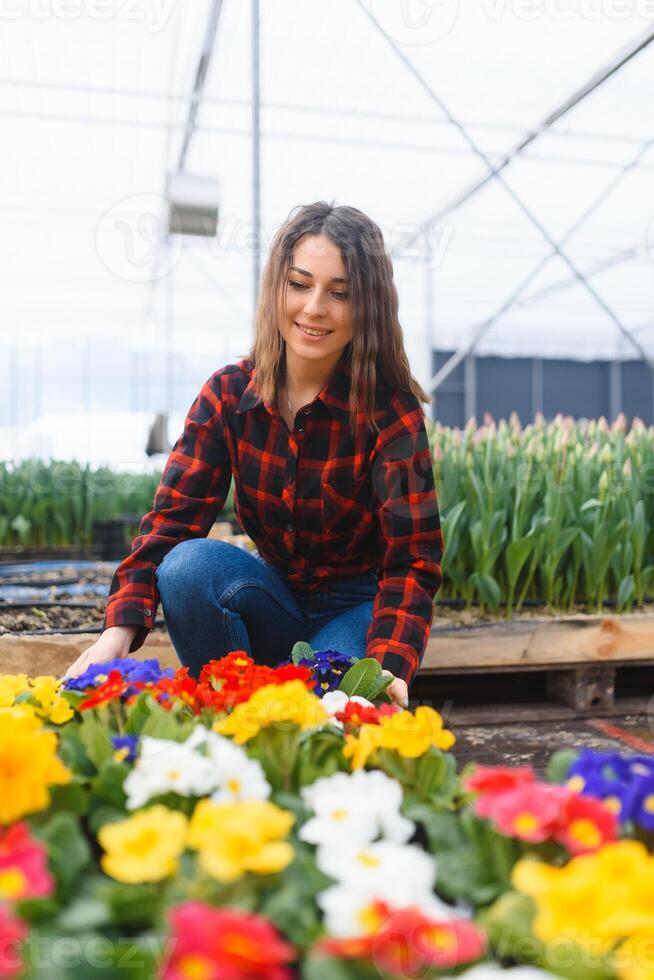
316,840 -> 436,908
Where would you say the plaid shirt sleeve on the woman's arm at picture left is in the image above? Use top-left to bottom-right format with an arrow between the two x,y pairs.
103,369 -> 231,653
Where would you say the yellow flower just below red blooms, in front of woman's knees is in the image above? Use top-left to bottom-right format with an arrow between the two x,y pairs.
213,680 -> 329,745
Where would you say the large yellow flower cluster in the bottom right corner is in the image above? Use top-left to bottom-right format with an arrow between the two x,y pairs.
512,840 -> 654,952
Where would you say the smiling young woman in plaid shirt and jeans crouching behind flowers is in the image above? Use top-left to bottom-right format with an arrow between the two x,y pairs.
67,201 -> 443,704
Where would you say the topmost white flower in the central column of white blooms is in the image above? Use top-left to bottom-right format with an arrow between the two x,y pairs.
299,769 -> 415,846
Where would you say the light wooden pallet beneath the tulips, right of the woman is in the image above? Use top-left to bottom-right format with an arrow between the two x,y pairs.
411,614 -> 654,724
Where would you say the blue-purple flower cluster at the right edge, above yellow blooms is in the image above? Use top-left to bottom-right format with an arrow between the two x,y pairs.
566,749 -> 654,830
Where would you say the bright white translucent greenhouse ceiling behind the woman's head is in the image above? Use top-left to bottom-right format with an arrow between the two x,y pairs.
0,0 -> 654,404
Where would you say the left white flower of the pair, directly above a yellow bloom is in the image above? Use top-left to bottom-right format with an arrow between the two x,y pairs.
123,735 -> 216,810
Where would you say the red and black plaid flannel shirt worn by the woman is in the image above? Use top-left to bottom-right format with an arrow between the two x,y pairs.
103,352 -> 443,682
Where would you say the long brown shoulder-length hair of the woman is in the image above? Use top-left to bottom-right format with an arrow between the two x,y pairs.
249,201 -> 432,433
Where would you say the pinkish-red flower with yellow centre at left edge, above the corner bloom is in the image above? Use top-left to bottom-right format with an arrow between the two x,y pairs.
0,822 -> 54,901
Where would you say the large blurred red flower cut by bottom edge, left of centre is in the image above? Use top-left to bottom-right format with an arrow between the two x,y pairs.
159,901 -> 296,980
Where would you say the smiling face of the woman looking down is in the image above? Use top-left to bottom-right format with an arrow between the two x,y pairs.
280,235 -> 353,366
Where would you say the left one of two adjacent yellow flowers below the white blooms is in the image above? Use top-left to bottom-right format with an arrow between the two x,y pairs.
98,804 -> 188,884
